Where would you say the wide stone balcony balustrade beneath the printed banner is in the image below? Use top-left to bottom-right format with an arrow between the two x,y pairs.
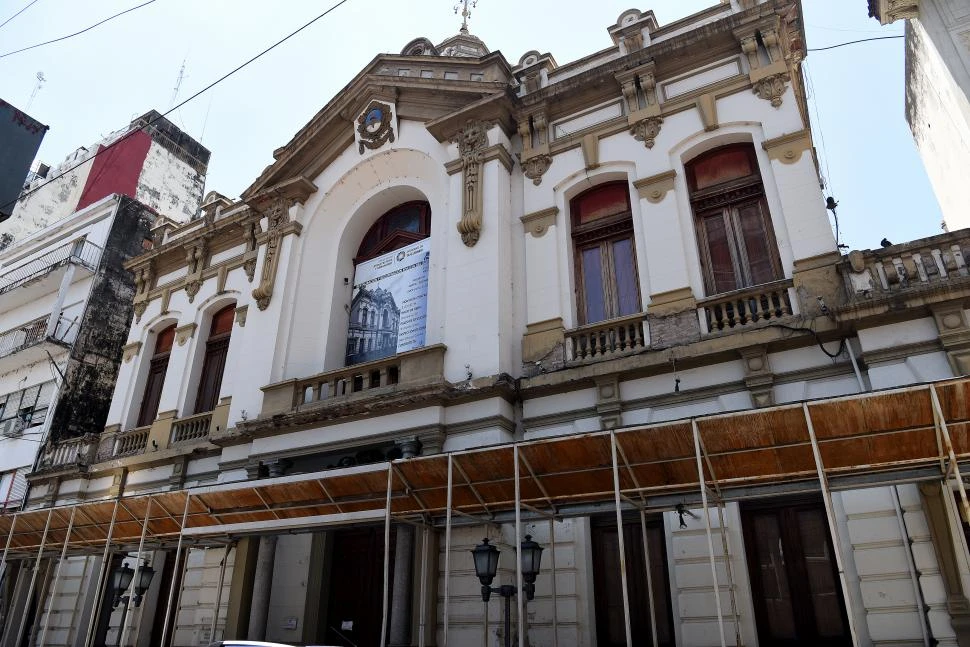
263,344 -> 445,414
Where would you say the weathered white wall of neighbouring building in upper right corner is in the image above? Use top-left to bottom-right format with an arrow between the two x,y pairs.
869,0 -> 970,230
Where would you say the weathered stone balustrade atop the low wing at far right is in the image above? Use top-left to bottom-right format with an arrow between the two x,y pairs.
841,229 -> 970,301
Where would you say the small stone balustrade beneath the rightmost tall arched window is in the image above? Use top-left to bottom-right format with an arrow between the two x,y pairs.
697,279 -> 794,333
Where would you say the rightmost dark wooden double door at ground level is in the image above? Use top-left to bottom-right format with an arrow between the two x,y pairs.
742,501 -> 851,647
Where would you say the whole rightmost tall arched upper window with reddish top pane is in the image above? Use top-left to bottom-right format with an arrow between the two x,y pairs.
687,144 -> 782,295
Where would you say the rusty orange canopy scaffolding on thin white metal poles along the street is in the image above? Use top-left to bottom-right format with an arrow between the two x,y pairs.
0,379 -> 970,647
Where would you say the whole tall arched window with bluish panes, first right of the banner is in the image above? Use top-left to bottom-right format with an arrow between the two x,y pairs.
569,182 -> 640,324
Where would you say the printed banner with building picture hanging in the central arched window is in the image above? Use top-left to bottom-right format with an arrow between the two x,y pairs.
346,238 -> 431,366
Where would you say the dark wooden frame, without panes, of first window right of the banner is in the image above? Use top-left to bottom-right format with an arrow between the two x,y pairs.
569,180 -> 643,326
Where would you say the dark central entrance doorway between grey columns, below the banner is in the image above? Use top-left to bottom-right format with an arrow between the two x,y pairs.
322,526 -> 394,647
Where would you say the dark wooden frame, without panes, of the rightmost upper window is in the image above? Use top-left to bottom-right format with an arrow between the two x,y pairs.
685,143 -> 784,296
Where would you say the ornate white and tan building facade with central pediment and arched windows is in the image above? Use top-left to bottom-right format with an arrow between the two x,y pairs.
0,0 -> 970,647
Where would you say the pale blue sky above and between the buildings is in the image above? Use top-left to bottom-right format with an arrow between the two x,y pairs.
0,0 -> 942,249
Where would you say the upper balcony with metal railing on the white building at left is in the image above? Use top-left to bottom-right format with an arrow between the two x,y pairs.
0,238 -> 102,310
